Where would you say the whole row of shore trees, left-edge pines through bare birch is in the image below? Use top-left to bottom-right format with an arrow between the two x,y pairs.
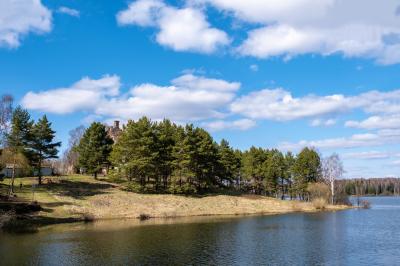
0,97 -> 343,202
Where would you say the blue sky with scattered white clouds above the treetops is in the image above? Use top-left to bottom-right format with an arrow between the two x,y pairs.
0,0 -> 400,177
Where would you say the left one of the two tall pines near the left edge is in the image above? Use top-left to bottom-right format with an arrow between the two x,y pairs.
6,107 -> 33,194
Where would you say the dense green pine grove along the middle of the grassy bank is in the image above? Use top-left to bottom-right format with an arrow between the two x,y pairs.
73,117 -> 330,199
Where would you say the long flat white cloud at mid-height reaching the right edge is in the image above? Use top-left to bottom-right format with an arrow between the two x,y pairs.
230,88 -> 400,122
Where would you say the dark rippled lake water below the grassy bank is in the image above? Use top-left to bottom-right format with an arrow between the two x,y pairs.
0,197 -> 400,265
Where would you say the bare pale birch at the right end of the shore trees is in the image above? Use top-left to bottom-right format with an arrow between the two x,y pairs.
322,153 -> 344,204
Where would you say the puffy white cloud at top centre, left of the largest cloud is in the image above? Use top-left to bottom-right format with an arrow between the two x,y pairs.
117,0 -> 230,53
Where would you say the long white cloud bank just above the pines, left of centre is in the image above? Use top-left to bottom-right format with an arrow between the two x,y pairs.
22,74 -> 244,122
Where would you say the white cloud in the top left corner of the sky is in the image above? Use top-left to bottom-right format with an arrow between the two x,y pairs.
0,0 -> 52,48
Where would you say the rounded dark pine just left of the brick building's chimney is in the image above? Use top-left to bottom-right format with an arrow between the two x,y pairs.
77,122 -> 113,179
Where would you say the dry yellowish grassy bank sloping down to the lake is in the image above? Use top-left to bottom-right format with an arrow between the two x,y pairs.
0,176 -> 351,231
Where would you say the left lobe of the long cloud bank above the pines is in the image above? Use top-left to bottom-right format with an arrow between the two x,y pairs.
22,75 -> 120,114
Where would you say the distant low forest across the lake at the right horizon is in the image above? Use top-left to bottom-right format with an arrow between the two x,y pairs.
337,178 -> 400,196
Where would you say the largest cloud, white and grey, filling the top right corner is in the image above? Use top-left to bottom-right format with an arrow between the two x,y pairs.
192,0 -> 400,64
